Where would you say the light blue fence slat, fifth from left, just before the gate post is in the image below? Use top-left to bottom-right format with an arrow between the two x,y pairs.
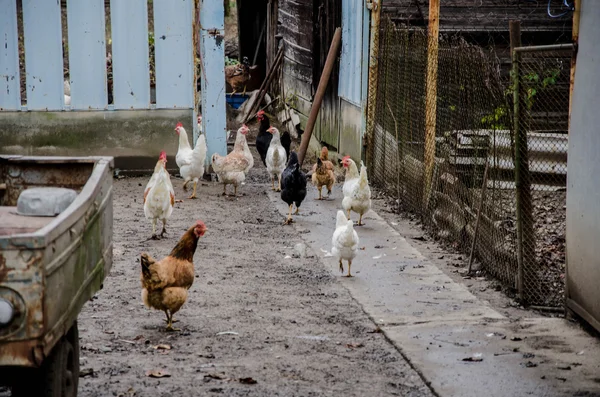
154,0 -> 194,109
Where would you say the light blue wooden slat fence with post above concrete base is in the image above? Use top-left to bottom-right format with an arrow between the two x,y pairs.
0,0 -> 227,162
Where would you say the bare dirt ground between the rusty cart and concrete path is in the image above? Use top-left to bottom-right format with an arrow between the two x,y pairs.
72,150 -> 431,397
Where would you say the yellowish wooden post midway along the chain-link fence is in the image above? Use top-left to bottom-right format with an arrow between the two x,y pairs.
423,0 -> 440,210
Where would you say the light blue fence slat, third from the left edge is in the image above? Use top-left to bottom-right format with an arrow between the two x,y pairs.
67,0 -> 108,109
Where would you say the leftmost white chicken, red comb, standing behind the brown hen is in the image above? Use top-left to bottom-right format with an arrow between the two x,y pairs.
144,151 -> 175,240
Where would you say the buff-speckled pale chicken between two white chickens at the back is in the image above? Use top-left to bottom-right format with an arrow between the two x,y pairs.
211,126 -> 248,196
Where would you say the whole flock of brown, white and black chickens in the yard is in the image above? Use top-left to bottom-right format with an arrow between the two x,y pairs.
140,111 -> 371,331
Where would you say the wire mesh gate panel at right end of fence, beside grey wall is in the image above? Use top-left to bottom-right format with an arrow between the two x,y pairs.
512,44 -> 573,306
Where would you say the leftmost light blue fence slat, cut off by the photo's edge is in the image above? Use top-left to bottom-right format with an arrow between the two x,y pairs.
0,0 -> 21,110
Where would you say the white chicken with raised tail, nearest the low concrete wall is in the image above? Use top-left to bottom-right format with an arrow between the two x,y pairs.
175,120 -> 206,199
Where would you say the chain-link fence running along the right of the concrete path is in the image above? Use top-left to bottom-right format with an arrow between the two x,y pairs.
367,18 -> 570,307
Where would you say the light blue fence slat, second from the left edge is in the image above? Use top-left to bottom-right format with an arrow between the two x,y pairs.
23,0 -> 64,110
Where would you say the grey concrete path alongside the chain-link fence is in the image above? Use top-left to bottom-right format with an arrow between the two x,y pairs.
269,184 -> 600,397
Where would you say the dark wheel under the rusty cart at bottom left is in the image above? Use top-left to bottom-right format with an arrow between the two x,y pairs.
12,321 -> 79,397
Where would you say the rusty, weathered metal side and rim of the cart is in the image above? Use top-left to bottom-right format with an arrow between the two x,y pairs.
0,156 -> 113,366
